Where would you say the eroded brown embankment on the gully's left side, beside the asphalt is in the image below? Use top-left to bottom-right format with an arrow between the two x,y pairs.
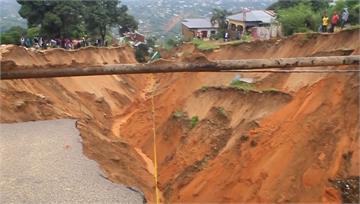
0,46 -> 153,199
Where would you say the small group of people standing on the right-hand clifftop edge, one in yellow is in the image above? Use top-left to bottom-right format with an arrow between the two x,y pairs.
319,8 -> 349,33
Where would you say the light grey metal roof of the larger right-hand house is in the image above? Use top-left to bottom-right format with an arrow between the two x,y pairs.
227,10 -> 275,23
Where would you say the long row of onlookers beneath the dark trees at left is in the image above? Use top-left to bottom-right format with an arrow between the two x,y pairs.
20,36 -> 108,49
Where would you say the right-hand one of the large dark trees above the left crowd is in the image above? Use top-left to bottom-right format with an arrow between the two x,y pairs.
84,0 -> 137,41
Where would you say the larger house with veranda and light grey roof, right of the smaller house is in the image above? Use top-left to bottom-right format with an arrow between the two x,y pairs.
226,10 -> 281,39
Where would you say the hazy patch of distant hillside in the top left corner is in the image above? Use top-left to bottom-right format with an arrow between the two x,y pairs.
0,0 -> 27,32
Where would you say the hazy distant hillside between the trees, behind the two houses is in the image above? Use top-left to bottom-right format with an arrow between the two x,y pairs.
121,0 -> 276,37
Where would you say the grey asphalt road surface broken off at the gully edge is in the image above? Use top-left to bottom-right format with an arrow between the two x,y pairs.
0,120 -> 143,203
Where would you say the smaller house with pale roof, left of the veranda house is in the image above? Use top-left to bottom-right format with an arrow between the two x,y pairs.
181,18 -> 219,40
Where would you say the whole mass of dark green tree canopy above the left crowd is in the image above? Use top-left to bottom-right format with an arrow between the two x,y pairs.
17,0 -> 137,41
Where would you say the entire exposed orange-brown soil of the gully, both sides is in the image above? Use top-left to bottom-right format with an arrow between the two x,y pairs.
0,30 -> 360,202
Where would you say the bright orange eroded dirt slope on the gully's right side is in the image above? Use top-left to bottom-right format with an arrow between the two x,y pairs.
122,30 -> 359,202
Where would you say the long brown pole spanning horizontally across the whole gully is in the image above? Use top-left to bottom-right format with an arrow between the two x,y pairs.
0,55 -> 360,79
